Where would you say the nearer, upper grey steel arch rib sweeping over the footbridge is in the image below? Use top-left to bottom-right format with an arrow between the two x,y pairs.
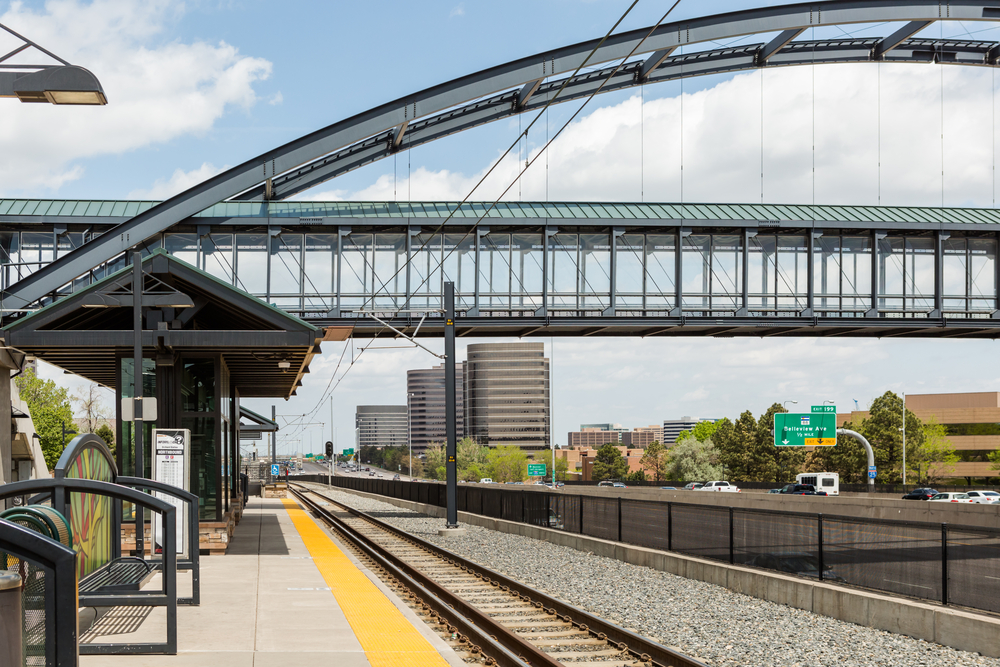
2,0 -> 1000,309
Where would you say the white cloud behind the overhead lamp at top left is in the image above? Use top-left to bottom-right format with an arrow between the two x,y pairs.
0,0 -> 271,194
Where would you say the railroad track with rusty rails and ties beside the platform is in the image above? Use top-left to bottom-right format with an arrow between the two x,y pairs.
289,483 -> 706,667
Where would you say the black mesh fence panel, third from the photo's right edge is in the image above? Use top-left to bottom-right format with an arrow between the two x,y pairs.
733,510 -> 819,576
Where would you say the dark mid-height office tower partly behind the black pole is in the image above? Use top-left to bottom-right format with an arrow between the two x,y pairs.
406,363 -> 465,451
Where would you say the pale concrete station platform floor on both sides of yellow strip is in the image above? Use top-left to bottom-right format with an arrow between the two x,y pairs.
80,498 -> 464,667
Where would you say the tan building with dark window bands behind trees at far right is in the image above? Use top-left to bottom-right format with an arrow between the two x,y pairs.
837,391 -> 1000,481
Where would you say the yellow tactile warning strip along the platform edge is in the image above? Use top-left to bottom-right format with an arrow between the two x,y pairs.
282,499 -> 448,667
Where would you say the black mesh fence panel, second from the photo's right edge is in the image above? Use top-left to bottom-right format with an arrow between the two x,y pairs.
823,516 -> 941,600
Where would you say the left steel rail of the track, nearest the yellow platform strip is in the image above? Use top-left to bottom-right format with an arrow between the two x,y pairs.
288,483 -> 562,667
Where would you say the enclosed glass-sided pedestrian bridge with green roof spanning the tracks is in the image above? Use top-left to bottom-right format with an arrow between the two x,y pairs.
0,200 -> 1000,338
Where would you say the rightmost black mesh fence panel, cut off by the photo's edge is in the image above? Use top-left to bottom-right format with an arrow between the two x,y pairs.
948,526 -> 1000,612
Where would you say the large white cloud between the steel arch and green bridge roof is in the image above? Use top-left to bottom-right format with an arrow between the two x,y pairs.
322,64 -> 994,206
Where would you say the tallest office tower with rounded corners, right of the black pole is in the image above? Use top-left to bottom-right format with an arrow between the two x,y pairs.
463,343 -> 550,449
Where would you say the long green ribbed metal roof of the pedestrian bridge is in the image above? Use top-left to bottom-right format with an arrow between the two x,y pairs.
0,199 -> 1000,225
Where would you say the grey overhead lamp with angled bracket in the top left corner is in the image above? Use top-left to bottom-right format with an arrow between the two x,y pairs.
0,23 -> 108,106
